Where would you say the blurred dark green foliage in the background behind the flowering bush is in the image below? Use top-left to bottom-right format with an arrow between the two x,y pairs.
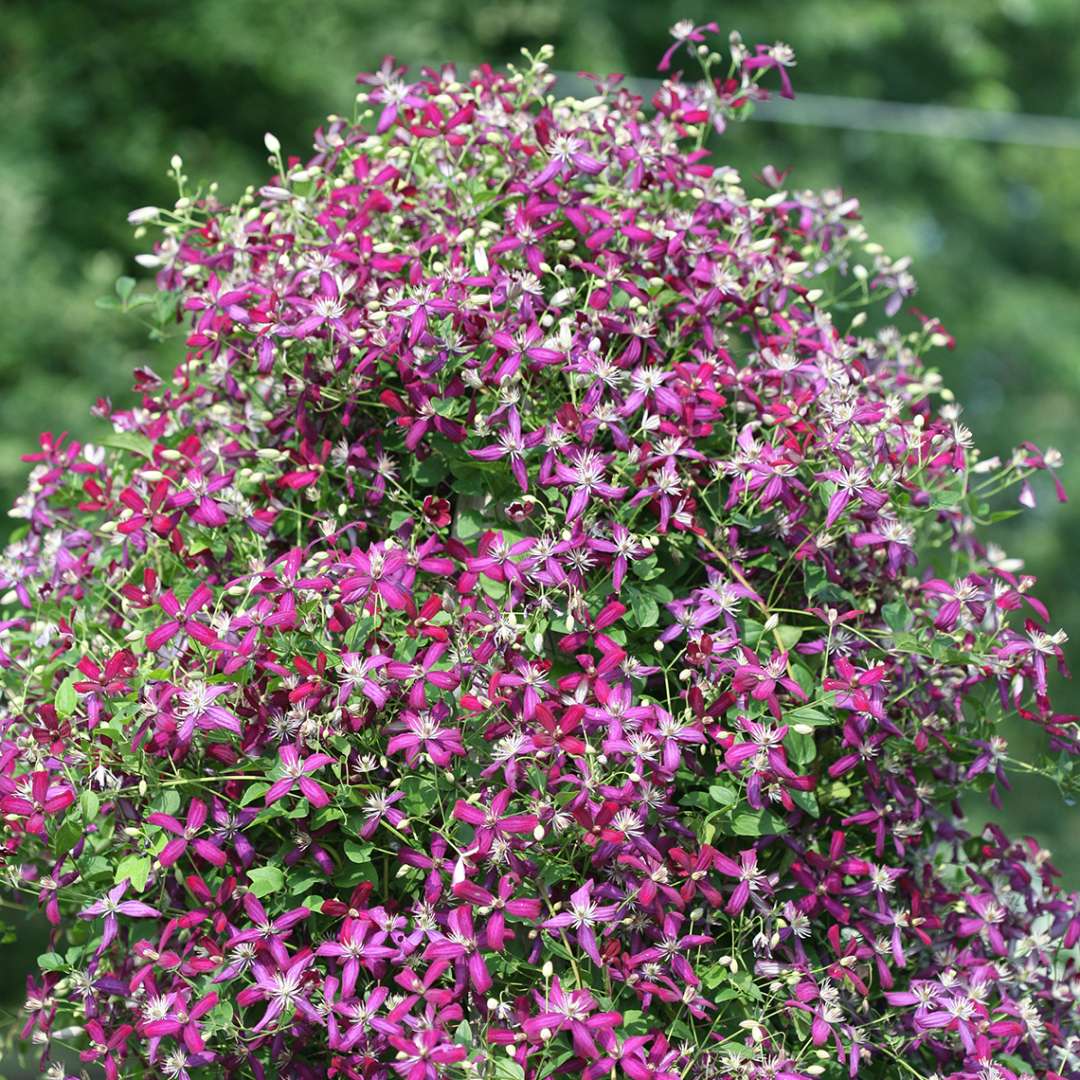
0,0 -> 1080,1049
